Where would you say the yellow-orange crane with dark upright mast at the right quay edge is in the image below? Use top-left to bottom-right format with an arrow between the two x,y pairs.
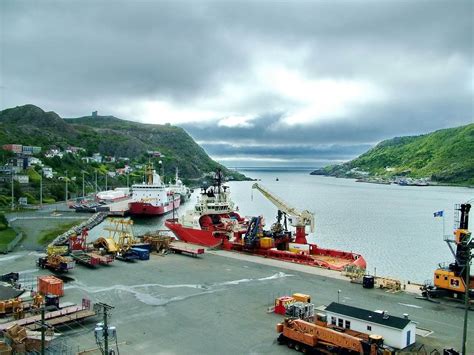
421,203 -> 474,299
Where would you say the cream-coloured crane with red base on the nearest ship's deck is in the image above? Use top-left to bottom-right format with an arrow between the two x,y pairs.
252,183 -> 314,244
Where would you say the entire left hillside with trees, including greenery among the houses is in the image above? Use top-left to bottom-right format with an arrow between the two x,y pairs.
0,105 -> 245,205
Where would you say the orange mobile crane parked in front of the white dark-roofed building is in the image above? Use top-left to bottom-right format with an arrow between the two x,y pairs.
276,318 -> 390,355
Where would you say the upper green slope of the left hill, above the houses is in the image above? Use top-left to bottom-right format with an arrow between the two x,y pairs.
0,105 -> 244,179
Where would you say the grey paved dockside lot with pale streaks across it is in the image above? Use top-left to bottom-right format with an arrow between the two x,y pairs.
0,249 -> 474,354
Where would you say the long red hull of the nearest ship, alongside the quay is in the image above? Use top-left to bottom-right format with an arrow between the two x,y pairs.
165,219 -> 367,271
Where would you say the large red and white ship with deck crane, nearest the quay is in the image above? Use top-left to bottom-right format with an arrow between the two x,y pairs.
165,171 -> 366,271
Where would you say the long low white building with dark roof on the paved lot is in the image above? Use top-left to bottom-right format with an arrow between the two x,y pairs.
325,302 -> 416,349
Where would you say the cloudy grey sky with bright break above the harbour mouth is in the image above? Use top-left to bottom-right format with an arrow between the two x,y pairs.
0,0 -> 474,167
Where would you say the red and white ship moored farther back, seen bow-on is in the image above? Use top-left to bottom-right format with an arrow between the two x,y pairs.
128,166 -> 181,216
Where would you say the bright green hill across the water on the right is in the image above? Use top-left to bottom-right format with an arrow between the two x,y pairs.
312,124 -> 474,186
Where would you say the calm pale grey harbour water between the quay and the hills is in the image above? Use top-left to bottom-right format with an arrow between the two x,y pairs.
91,170 -> 474,282
